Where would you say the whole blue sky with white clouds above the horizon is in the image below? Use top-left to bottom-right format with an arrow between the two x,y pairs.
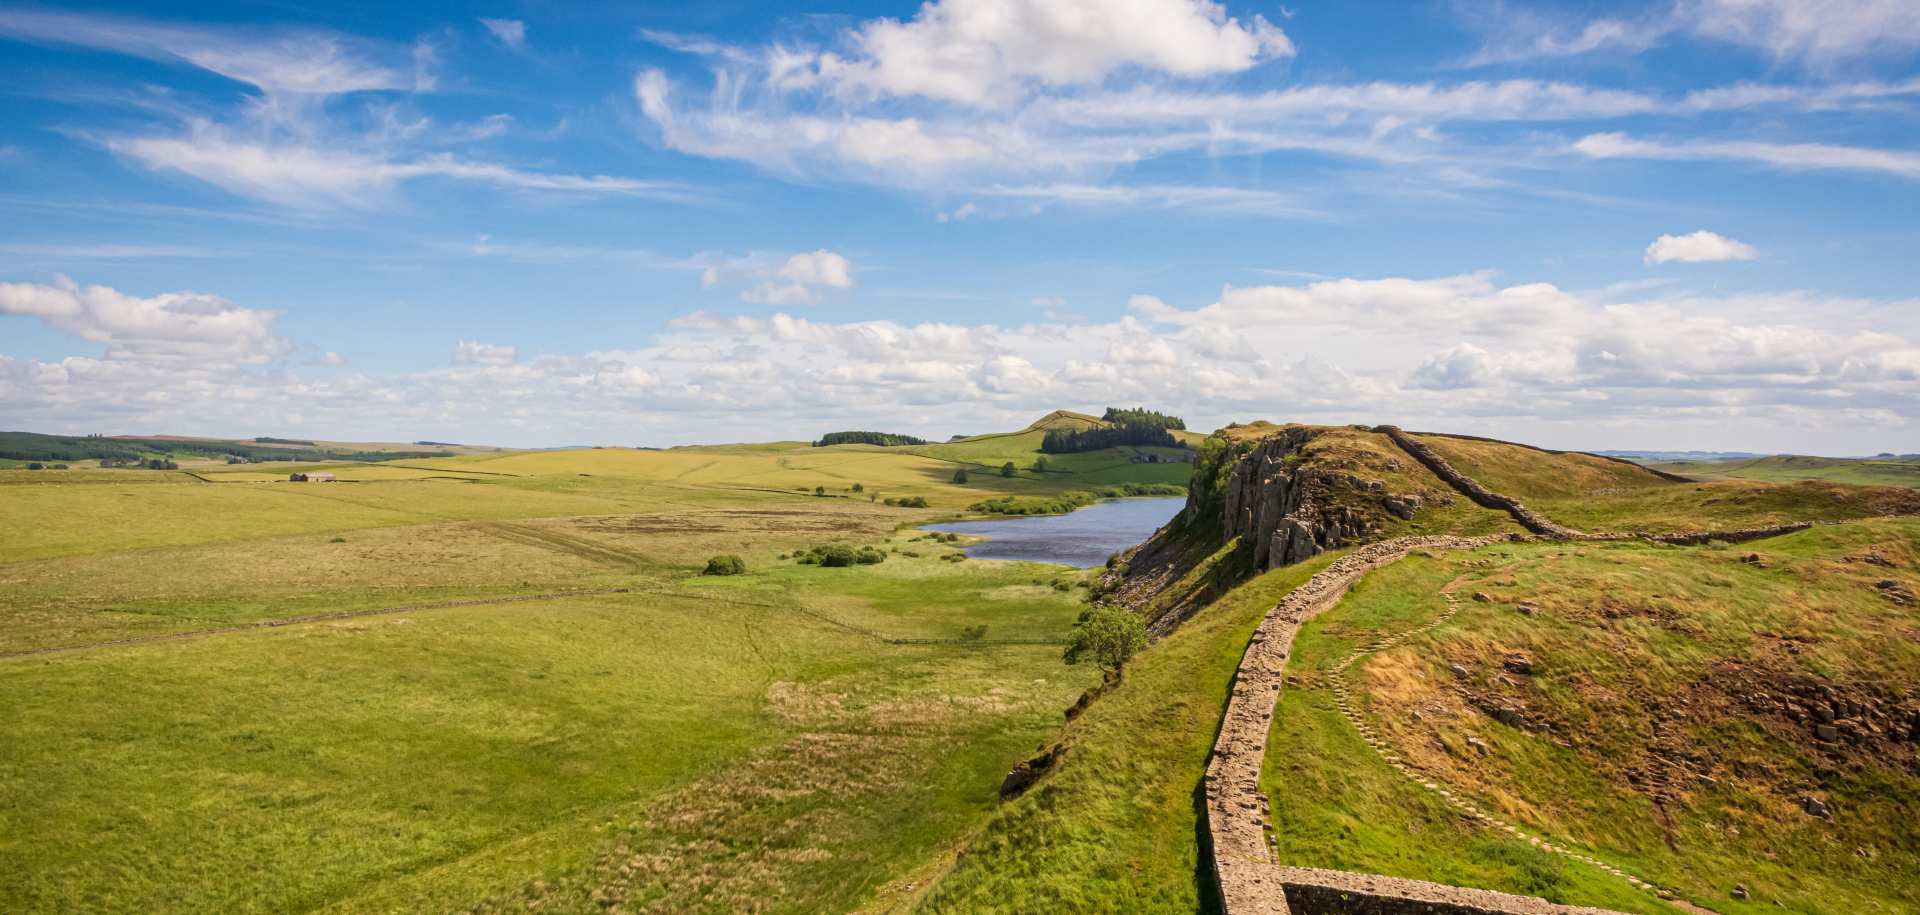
0,0 -> 1920,455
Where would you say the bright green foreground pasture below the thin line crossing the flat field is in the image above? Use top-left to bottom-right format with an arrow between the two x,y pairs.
0,544 -> 1087,911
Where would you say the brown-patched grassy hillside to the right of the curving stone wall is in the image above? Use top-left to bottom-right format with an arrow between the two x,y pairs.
1267,520 -> 1920,913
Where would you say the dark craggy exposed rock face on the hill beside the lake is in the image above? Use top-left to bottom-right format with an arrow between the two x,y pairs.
1221,428 -> 1421,570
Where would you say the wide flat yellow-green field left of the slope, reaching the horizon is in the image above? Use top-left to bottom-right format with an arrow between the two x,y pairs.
0,416 -> 1198,913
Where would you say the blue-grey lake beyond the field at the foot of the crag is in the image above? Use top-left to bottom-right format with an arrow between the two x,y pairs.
925,497 -> 1187,568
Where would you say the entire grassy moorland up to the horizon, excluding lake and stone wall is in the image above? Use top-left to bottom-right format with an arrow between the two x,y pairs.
0,411 -> 1920,913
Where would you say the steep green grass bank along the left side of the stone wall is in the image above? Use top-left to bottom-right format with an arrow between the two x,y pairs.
920,556 -> 1327,913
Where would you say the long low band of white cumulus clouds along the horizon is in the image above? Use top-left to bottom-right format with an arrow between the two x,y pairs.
0,266 -> 1920,451
